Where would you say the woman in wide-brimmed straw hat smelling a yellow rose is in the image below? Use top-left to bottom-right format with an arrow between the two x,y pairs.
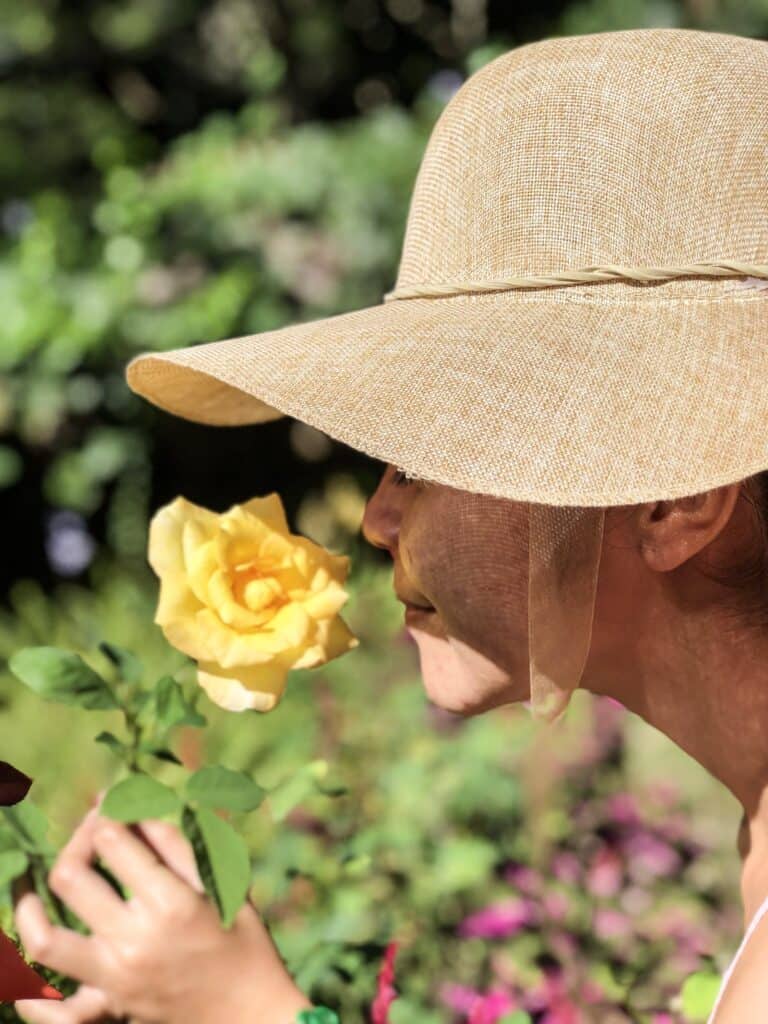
10,24 -> 768,1024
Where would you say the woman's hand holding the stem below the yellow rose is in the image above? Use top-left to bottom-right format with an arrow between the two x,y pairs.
14,808 -> 311,1024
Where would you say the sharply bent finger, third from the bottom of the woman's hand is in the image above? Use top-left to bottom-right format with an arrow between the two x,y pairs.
48,811 -> 129,935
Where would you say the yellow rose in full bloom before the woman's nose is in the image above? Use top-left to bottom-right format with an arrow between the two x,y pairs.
148,494 -> 359,711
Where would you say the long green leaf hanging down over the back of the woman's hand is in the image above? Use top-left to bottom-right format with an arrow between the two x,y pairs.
181,807 -> 251,928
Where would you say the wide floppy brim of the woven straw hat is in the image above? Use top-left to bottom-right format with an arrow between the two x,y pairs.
126,285 -> 768,506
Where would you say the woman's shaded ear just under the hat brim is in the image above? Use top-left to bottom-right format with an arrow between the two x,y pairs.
637,481 -> 741,572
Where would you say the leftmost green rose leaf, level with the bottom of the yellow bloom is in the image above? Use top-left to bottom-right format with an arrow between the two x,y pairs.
8,647 -> 120,711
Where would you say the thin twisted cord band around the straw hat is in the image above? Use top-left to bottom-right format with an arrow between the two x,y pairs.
384,260 -> 768,302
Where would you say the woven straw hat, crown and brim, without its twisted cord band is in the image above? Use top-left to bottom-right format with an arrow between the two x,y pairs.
126,29 -> 768,506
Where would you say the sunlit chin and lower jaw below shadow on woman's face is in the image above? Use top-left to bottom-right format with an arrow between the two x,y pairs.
409,626 -> 528,718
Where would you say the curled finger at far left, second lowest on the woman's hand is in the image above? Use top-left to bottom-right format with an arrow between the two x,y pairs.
14,892 -> 102,986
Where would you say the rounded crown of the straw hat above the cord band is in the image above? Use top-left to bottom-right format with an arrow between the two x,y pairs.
396,29 -> 768,300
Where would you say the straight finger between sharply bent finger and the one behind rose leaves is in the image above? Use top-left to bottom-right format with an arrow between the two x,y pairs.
93,818 -> 198,911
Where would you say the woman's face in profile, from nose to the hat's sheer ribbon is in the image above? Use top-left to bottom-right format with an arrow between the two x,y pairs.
362,465 -> 529,715
